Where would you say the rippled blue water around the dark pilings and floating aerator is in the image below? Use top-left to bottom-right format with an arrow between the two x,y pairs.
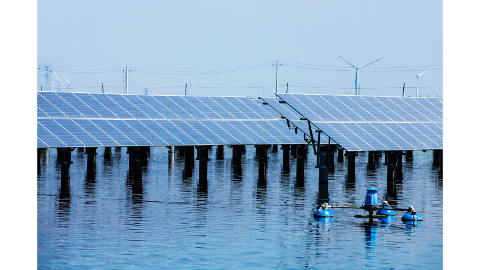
37,146 -> 443,269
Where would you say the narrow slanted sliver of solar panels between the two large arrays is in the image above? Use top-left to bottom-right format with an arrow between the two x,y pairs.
262,97 -> 334,144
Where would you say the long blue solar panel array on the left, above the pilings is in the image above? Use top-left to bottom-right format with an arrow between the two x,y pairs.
37,92 -> 305,148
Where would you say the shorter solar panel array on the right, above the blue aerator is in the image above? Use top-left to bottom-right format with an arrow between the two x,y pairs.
277,94 -> 443,151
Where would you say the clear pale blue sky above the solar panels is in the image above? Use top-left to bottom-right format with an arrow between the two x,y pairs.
37,0 -> 443,99
